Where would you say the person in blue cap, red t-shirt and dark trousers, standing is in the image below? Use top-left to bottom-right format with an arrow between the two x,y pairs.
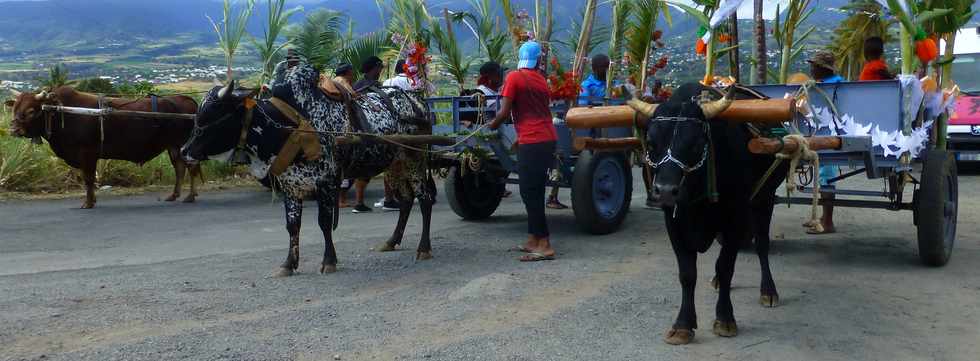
489,41 -> 558,262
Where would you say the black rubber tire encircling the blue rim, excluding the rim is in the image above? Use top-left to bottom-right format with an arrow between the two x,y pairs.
572,150 -> 633,235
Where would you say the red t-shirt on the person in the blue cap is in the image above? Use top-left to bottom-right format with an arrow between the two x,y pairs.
500,69 -> 558,144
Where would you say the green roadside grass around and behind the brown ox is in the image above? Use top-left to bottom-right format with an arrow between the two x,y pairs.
0,101 -> 248,193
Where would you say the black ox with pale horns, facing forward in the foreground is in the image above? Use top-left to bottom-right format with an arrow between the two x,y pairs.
631,83 -> 786,345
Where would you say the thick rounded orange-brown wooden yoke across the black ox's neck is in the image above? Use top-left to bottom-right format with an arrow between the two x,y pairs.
565,99 -> 795,129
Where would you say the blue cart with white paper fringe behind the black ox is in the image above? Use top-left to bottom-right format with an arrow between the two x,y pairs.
751,80 -> 958,266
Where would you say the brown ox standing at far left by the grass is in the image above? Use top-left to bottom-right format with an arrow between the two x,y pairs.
5,86 -> 201,208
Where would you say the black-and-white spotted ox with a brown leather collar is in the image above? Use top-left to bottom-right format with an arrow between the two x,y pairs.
182,62 -> 436,276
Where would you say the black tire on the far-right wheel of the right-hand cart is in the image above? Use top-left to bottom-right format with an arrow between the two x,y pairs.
915,150 -> 959,267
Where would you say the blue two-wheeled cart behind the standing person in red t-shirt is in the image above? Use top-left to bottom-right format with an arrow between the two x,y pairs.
428,96 -> 633,234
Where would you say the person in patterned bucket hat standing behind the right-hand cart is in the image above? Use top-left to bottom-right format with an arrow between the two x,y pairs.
804,50 -> 844,234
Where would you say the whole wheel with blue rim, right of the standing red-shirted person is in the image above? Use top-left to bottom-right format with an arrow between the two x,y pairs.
572,151 -> 633,234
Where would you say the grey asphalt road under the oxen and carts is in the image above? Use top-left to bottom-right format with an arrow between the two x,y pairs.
0,172 -> 980,360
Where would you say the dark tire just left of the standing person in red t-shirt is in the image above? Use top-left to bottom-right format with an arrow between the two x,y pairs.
443,165 -> 506,221
